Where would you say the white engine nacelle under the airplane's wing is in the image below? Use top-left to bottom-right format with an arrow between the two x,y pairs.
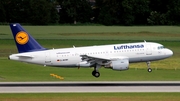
105,59 -> 129,71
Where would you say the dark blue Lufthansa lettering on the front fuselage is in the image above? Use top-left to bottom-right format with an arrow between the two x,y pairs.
114,45 -> 144,50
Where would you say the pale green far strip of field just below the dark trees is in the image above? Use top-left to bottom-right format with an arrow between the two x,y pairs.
0,26 -> 180,41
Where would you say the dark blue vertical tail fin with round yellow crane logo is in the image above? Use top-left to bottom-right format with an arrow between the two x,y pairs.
10,23 -> 46,53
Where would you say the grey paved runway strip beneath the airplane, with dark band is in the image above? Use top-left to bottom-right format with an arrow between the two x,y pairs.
0,81 -> 180,93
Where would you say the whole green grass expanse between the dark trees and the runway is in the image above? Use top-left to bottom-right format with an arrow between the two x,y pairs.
0,26 -> 180,81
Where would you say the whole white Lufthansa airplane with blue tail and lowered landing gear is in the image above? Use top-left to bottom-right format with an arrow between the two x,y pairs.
9,23 -> 173,78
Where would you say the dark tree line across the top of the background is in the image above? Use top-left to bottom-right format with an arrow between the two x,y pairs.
0,0 -> 180,25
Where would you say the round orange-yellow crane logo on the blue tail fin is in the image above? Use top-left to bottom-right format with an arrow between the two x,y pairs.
16,31 -> 29,45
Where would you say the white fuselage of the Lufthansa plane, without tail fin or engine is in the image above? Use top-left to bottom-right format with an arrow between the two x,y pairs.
9,42 -> 173,67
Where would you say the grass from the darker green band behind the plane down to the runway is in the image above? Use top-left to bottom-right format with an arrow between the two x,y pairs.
0,39 -> 180,82
